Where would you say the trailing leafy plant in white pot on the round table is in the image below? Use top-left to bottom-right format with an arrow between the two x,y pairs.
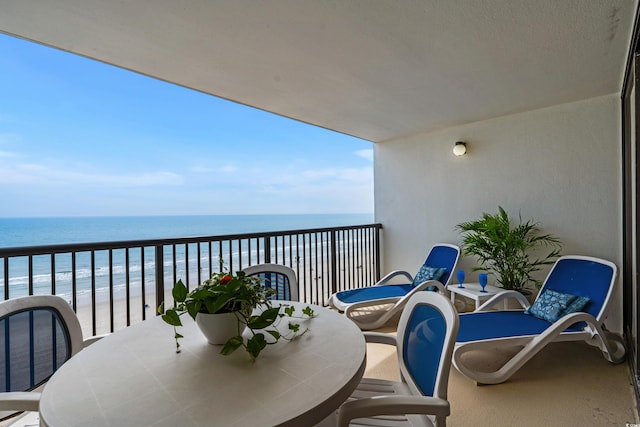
158,271 -> 314,360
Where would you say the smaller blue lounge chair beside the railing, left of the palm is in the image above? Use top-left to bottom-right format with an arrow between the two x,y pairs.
329,243 -> 460,330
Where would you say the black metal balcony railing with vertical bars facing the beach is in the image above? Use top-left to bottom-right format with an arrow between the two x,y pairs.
0,224 -> 382,335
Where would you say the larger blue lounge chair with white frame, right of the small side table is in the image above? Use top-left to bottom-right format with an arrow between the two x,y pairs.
453,255 -> 625,384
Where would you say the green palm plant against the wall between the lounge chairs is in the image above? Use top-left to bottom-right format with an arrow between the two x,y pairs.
456,206 -> 562,295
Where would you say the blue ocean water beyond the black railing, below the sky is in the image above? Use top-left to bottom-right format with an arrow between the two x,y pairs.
0,214 -> 373,297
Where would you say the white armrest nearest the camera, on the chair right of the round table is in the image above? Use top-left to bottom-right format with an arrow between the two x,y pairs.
338,396 -> 451,427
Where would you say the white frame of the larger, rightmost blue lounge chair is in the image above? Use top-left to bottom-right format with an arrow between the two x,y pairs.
453,255 -> 626,384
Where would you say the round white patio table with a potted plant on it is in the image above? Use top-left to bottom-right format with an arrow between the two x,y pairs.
40,302 -> 366,427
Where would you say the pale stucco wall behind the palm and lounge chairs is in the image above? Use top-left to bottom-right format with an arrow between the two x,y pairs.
375,94 -> 622,330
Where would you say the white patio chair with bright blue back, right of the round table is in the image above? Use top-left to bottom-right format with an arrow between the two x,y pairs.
332,292 -> 458,427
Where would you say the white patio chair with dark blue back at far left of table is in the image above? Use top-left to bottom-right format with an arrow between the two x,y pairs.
0,295 -> 101,419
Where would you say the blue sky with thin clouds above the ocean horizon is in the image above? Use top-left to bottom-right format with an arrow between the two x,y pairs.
0,34 -> 373,217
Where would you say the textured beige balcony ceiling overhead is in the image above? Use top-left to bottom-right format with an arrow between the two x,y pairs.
0,0 -> 636,142
